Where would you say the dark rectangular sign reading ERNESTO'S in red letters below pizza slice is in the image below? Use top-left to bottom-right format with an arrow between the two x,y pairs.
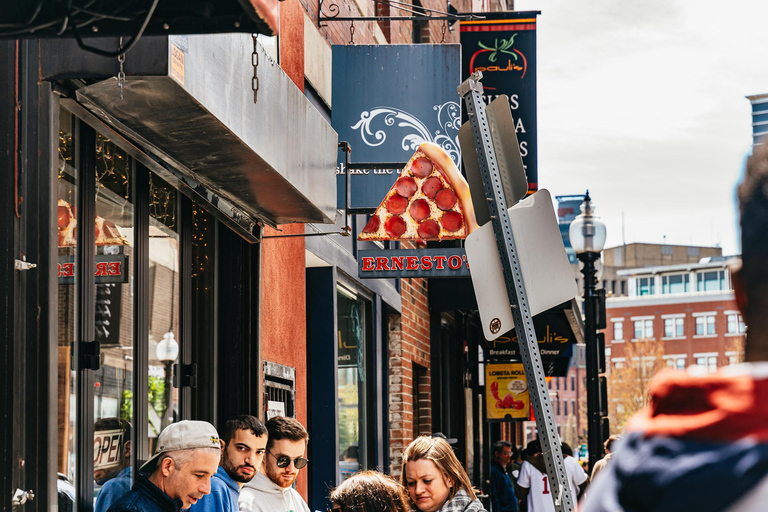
357,247 -> 469,279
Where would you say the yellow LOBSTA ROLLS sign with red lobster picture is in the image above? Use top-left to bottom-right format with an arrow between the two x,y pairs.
485,363 -> 531,420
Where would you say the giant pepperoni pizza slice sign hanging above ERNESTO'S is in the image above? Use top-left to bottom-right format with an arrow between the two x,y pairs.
357,142 -> 478,240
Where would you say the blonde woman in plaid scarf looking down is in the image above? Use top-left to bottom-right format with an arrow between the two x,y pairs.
402,436 -> 486,512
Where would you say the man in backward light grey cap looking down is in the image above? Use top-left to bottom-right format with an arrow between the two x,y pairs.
109,420 -> 221,512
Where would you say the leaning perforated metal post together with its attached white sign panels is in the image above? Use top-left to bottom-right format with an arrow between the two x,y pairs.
459,72 -> 575,512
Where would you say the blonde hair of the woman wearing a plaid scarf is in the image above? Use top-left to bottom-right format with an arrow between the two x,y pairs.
401,436 -> 477,501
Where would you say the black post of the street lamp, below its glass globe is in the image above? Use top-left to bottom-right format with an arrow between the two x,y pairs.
578,252 -> 603,471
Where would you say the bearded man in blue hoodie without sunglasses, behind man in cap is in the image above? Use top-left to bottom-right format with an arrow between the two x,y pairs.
190,414 -> 267,512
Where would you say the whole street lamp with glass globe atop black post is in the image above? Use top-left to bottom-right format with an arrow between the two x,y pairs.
568,190 -> 606,471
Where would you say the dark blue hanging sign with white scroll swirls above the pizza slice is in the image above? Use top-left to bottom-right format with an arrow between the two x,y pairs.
331,44 -> 461,213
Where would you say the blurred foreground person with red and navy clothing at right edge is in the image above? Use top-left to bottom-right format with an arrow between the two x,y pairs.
581,139 -> 768,512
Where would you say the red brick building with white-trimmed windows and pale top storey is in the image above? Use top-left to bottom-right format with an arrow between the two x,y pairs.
605,258 -> 745,374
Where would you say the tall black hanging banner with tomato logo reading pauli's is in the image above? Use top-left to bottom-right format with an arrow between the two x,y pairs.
460,11 -> 539,194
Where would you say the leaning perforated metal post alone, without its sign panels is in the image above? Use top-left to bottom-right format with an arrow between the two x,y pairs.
458,72 -> 574,512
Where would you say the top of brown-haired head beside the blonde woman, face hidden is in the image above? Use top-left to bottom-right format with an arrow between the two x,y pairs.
330,471 -> 410,512
